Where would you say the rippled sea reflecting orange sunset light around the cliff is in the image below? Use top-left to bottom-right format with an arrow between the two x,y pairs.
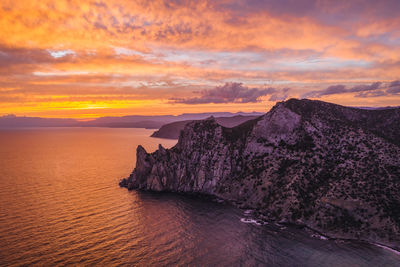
0,128 -> 400,266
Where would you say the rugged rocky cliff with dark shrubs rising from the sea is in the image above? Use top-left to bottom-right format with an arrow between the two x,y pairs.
121,99 -> 400,248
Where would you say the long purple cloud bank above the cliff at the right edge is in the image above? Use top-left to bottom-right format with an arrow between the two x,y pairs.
302,81 -> 400,98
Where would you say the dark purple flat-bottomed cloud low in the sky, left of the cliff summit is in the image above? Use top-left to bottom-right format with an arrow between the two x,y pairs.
170,83 -> 276,104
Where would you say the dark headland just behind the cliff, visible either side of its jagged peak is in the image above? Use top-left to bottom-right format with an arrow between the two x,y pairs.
151,115 -> 260,139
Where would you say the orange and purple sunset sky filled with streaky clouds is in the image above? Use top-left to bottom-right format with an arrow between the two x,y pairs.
0,0 -> 400,118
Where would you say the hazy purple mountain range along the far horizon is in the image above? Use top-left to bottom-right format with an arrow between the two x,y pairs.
0,112 -> 262,129
